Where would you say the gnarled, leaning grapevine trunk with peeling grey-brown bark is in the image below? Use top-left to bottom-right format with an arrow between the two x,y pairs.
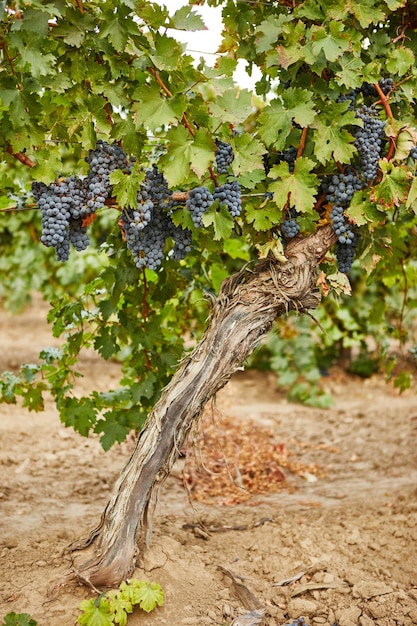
61,226 -> 335,588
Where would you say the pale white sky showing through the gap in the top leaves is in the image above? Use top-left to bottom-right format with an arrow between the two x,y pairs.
154,0 -> 260,90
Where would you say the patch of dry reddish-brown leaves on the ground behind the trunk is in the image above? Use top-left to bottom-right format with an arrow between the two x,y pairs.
183,409 -> 324,505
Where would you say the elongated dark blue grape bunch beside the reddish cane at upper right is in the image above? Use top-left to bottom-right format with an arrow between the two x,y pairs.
354,106 -> 385,182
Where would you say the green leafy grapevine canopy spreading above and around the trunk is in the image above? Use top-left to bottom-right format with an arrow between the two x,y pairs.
0,0 -> 417,448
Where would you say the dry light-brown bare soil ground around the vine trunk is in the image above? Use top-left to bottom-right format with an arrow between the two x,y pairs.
0,302 -> 417,626
